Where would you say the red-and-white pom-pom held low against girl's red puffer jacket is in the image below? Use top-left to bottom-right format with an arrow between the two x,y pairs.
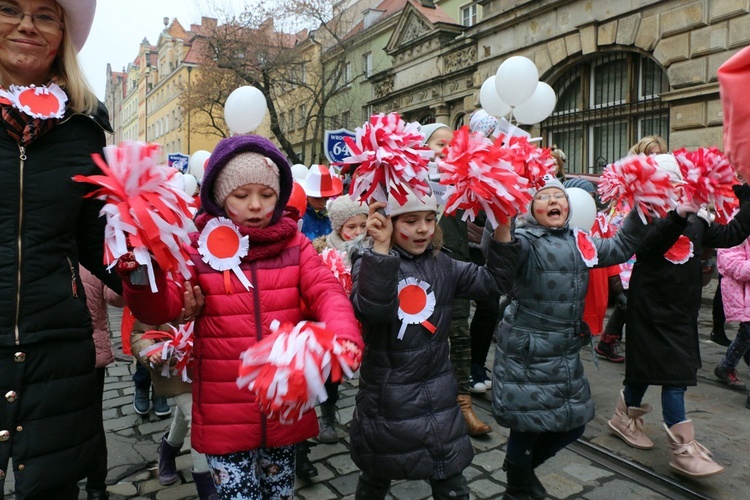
237,321 -> 361,424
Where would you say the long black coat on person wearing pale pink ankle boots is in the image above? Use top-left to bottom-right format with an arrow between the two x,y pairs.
625,204 -> 750,386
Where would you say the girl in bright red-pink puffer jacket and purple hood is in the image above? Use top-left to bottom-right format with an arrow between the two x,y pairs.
118,135 -> 363,498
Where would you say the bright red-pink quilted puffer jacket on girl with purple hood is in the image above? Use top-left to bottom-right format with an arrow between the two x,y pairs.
123,229 -> 363,455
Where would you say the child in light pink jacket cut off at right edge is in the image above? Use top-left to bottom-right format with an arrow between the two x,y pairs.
714,184 -> 750,409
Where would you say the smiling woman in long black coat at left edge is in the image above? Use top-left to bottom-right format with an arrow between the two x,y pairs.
0,0 -> 121,499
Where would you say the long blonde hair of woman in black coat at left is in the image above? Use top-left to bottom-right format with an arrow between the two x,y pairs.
50,9 -> 99,114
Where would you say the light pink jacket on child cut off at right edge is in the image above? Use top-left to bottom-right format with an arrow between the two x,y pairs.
717,239 -> 750,321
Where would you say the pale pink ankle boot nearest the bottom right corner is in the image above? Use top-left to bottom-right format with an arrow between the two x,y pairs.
664,420 -> 724,479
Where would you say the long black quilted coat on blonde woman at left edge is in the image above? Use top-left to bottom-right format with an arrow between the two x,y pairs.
0,106 -> 121,498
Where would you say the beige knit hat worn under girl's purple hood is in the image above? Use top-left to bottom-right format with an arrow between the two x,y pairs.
214,153 -> 279,206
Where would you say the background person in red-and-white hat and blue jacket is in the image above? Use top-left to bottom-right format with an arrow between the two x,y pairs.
302,165 -> 344,241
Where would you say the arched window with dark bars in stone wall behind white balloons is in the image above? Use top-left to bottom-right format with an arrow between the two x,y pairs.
542,52 -> 669,173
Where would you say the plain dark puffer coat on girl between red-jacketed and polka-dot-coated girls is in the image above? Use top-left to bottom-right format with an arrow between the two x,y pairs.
350,238 -> 518,479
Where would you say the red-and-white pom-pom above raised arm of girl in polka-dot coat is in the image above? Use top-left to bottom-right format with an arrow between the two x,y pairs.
599,154 -> 677,223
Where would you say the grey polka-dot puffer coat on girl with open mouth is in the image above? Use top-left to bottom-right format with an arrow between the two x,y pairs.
492,211 -> 684,432
